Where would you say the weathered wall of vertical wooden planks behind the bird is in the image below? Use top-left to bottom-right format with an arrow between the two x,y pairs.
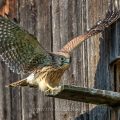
0,0 -> 119,120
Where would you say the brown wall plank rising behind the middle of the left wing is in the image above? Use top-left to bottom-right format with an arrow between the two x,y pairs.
18,0 -> 37,120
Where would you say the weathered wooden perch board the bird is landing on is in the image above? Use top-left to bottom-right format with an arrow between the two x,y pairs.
46,85 -> 120,106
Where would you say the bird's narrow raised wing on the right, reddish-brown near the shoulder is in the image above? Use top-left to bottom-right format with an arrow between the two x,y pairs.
59,8 -> 120,53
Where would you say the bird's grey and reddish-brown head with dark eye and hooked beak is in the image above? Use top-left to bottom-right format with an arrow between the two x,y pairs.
50,52 -> 71,67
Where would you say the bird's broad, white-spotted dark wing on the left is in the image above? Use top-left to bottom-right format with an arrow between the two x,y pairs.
0,16 -> 50,73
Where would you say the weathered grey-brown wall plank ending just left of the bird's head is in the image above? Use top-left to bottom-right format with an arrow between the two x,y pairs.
36,0 -> 54,120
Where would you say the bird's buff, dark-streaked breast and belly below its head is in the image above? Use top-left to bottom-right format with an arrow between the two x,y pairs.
27,65 -> 69,91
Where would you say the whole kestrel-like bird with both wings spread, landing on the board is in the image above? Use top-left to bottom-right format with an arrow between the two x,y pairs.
0,6 -> 120,93
